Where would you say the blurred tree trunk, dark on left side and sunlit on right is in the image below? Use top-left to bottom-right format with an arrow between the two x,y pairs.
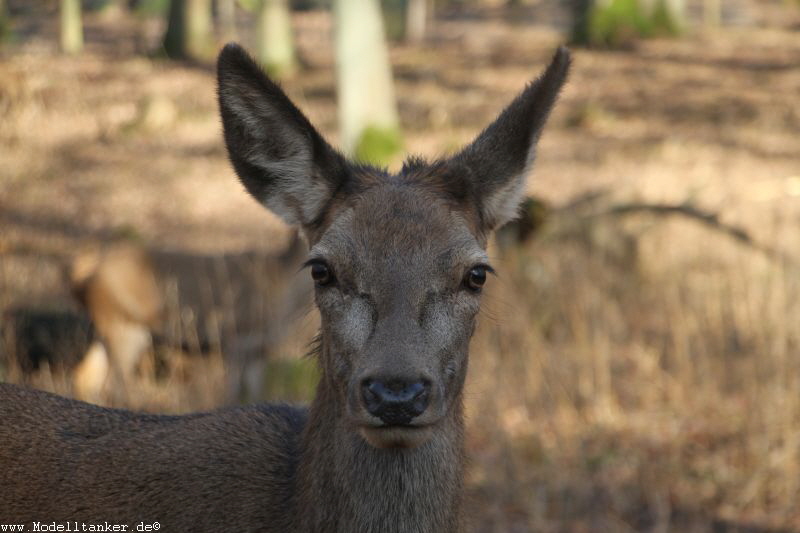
164,0 -> 214,59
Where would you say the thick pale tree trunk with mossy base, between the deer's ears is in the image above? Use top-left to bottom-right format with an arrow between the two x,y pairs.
334,0 -> 400,163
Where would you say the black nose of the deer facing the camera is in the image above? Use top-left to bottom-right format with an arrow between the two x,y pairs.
361,379 -> 431,426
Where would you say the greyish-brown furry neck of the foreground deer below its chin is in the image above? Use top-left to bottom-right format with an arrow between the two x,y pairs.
296,360 -> 464,533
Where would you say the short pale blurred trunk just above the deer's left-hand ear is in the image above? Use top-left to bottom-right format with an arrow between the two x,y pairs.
256,0 -> 297,79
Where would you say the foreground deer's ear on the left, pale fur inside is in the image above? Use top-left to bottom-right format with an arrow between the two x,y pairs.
217,44 -> 348,227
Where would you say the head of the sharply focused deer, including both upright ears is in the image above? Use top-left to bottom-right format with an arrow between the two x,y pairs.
218,45 -> 570,448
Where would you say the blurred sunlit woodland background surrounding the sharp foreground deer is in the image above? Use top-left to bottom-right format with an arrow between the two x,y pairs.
0,0 -> 800,533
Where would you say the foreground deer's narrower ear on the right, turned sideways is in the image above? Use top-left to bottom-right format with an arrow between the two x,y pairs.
450,47 -> 570,233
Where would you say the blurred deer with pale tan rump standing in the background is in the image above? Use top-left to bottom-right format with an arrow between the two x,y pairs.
70,235 -> 311,401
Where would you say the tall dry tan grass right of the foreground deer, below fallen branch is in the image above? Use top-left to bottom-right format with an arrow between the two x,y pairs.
470,215 -> 800,531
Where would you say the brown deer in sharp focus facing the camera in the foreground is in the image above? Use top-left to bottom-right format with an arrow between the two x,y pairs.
0,44 -> 570,533
